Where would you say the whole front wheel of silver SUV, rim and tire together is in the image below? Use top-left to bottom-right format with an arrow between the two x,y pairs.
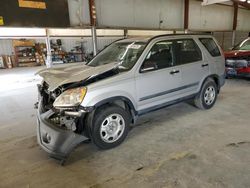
92,106 -> 130,149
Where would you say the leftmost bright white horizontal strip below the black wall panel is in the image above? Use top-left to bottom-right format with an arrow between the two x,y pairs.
0,27 -> 46,37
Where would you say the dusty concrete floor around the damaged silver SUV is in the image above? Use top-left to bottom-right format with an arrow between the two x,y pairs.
0,67 -> 250,188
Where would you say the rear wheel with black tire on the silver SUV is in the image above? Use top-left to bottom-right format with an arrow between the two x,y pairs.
194,78 -> 218,110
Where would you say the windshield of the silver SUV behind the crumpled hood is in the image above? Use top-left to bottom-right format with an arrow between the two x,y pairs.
87,42 -> 146,70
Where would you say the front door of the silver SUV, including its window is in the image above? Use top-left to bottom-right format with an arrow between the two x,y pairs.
135,40 -> 181,113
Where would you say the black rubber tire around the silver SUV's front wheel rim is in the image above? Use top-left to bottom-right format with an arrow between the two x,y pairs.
91,106 -> 130,149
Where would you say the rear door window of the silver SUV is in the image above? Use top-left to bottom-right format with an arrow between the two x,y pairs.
175,39 -> 202,65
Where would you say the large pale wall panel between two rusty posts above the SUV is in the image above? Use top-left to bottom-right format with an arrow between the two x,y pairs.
96,0 -> 184,29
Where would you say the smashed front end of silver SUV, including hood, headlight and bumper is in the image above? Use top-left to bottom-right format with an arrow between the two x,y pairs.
36,63 -> 119,160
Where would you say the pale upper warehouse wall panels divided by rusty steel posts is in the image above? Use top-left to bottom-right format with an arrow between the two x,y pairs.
68,0 -> 250,31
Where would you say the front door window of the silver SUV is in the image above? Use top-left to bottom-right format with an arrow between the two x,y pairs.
141,41 -> 174,71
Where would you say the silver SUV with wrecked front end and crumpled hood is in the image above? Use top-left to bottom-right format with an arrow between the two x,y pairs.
37,35 -> 225,159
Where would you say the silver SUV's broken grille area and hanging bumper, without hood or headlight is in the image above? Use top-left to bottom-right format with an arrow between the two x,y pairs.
37,82 -> 88,160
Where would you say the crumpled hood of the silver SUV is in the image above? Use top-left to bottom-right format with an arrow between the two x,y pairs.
36,63 -> 117,91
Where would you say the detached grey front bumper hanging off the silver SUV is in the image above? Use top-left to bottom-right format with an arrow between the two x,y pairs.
37,101 -> 88,160
